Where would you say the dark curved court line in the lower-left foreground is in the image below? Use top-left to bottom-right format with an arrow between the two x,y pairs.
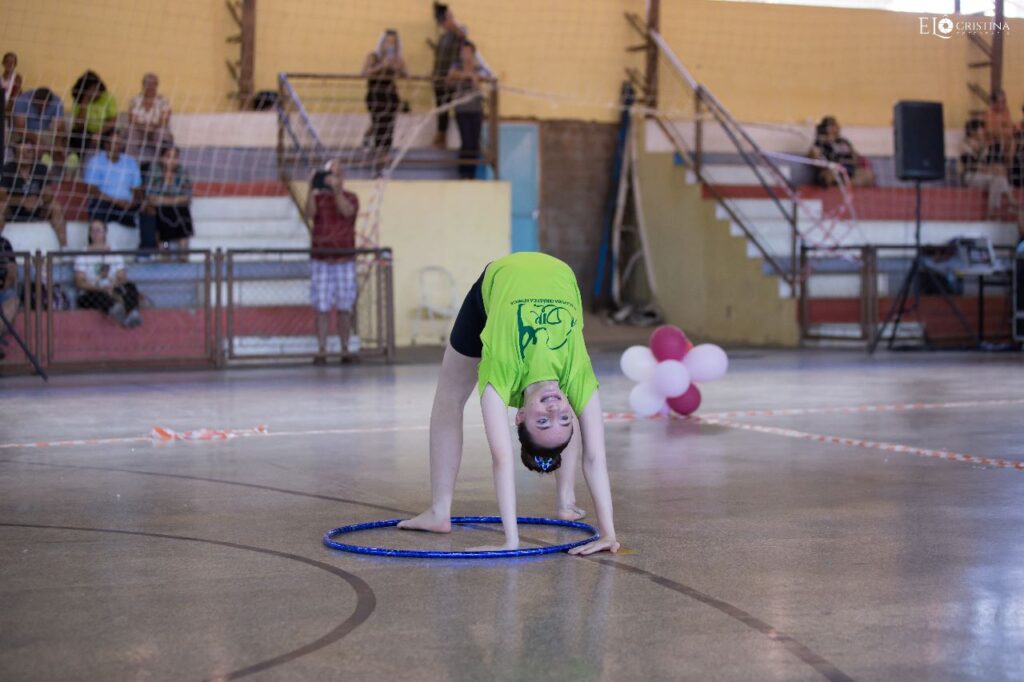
0,522 -> 377,682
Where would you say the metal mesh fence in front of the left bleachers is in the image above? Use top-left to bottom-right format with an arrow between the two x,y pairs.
0,248 -> 394,376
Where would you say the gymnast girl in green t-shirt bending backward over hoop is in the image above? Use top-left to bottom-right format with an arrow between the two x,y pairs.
398,253 -> 620,554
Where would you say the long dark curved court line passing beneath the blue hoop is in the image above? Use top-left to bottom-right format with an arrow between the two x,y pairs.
0,460 -> 853,682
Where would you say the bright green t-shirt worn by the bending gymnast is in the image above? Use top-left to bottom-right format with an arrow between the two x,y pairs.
478,252 -> 597,415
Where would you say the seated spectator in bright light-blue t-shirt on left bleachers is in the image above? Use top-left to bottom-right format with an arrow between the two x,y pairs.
84,130 -> 145,229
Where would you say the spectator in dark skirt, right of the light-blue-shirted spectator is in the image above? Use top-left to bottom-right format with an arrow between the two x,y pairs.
144,146 -> 193,260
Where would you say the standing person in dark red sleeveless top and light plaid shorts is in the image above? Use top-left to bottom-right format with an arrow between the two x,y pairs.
305,160 -> 359,365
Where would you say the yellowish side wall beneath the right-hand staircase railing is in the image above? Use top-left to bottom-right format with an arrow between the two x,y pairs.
640,148 -> 799,346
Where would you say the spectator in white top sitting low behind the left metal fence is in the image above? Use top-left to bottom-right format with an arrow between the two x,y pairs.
75,220 -> 142,328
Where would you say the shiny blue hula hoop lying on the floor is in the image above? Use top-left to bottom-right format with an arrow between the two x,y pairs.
324,516 -> 601,559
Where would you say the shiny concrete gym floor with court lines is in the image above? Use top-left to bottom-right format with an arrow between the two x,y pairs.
0,350 -> 1024,681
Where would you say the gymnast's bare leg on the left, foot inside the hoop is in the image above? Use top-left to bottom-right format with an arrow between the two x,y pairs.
398,343 -> 479,532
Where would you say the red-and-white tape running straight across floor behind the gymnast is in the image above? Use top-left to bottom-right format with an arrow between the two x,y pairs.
0,398 -> 1024,450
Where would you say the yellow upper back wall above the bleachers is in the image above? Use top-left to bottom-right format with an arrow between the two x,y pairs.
0,0 -> 1024,126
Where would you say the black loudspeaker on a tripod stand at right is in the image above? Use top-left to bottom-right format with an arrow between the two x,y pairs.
893,101 -> 946,180
